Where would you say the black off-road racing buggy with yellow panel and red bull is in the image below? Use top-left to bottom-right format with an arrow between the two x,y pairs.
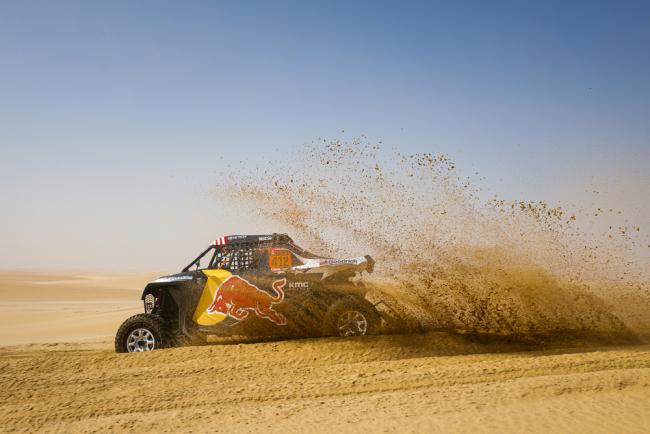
115,234 -> 381,352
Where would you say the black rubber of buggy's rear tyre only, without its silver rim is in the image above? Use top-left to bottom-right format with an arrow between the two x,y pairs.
323,297 -> 381,336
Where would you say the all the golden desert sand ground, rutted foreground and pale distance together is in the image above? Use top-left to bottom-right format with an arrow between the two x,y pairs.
0,272 -> 650,433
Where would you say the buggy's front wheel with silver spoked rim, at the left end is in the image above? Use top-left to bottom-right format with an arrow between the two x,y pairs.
115,313 -> 172,353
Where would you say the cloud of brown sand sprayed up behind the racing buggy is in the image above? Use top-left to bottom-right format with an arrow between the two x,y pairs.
224,141 -> 650,335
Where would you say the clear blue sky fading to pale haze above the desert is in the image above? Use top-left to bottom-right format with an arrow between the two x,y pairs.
0,1 -> 650,268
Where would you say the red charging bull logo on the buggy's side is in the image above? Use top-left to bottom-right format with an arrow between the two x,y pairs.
206,276 -> 287,325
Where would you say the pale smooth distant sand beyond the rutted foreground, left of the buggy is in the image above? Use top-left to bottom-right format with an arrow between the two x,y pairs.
0,271 -> 156,346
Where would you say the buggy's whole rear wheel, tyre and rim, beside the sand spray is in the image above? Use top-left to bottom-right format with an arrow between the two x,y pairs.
323,297 -> 381,336
